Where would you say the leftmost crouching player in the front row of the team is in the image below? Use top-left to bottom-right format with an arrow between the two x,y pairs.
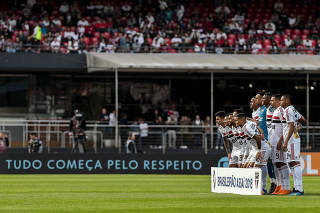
215,111 -> 231,160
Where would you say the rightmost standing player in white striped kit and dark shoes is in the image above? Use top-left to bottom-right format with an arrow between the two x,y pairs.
280,95 -> 305,196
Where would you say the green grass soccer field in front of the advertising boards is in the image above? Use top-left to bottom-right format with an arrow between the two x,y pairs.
0,175 -> 320,213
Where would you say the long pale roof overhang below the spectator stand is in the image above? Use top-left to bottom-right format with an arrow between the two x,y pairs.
87,53 -> 320,73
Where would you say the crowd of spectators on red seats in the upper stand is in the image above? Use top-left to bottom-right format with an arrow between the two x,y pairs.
0,0 -> 320,54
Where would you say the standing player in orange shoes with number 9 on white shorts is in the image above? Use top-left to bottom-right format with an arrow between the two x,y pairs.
270,94 -> 290,195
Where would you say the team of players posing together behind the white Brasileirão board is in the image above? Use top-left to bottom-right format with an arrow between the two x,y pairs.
215,92 -> 305,196
